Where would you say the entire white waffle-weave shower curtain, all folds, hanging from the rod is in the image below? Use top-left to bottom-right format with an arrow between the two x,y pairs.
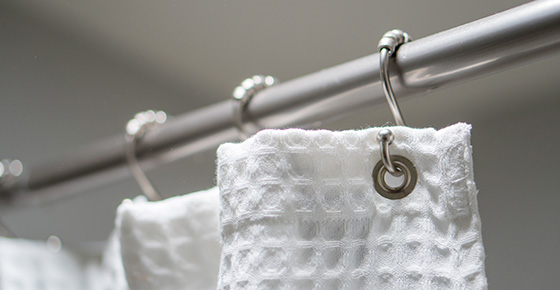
0,123 -> 487,290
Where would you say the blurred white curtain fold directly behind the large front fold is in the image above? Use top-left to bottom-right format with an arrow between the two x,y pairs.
117,188 -> 221,290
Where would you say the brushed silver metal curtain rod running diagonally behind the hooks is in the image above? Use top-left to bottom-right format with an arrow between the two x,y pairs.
0,0 -> 560,202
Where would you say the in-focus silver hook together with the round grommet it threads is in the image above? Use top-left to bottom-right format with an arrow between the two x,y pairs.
372,29 -> 418,199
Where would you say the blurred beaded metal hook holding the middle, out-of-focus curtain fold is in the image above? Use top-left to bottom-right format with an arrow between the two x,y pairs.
125,110 -> 167,201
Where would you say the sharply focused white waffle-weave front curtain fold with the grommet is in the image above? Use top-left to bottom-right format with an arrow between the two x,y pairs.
217,123 -> 487,289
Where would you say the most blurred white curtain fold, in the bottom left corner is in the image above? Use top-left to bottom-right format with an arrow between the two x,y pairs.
0,234 -> 128,290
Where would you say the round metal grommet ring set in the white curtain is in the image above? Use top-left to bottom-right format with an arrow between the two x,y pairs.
372,155 -> 418,199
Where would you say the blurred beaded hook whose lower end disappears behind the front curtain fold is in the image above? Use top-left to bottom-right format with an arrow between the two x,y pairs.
232,75 -> 278,141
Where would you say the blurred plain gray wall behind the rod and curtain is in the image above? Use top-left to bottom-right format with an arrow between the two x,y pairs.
0,0 -> 560,289
